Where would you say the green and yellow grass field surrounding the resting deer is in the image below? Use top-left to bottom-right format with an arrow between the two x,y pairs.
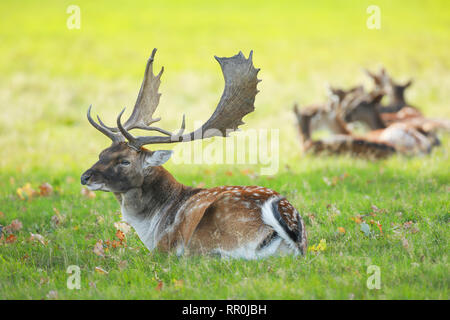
0,1 -> 450,299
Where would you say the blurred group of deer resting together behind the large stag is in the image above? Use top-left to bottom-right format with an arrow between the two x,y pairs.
294,69 -> 450,158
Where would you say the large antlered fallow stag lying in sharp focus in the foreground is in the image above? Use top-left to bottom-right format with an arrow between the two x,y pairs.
81,49 -> 307,259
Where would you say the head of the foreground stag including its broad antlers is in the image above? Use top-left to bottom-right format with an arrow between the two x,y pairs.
81,49 -> 260,193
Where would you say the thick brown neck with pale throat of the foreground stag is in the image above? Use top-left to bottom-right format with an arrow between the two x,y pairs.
116,167 -> 198,250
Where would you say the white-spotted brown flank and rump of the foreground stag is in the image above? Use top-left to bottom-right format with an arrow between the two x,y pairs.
185,186 -> 306,259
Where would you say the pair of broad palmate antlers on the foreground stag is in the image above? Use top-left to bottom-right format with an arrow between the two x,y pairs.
88,49 -> 260,150
